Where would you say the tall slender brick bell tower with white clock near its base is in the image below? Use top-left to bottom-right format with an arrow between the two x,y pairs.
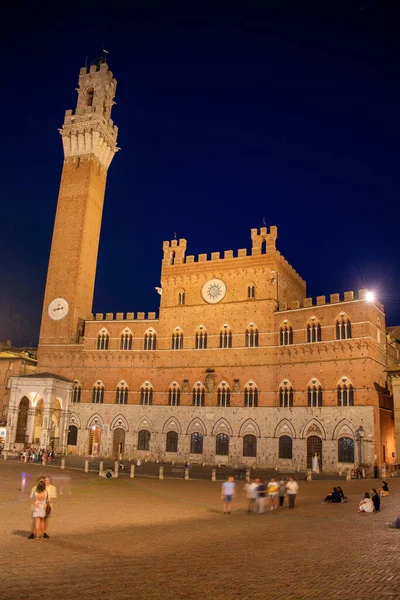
39,59 -> 118,345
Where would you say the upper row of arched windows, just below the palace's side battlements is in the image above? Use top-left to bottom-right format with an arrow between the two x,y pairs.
97,316 -> 352,350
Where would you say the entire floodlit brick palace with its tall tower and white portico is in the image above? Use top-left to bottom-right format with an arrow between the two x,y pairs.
3,61 -> 400,472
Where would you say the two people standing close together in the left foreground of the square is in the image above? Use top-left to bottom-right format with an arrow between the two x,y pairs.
28,475 -> 57,540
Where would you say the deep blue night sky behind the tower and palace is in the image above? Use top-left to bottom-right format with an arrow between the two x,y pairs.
0,0 -> 400,344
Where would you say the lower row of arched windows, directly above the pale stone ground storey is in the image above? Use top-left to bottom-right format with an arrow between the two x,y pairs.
72,378 -> 354,408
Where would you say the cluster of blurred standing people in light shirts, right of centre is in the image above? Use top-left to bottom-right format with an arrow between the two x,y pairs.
221,476 -> 299,515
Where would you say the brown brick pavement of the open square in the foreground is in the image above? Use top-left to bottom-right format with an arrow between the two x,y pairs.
0,462 -> 400,600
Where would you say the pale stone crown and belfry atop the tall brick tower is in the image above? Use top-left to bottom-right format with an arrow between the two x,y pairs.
59,61 -> 119,170
